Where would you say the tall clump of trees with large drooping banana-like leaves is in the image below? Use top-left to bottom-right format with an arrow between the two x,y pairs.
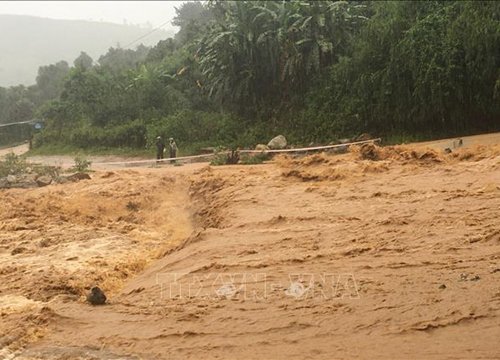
199,1 -> 364,113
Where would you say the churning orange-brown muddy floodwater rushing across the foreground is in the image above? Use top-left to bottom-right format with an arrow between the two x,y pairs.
0,136 -> 500,359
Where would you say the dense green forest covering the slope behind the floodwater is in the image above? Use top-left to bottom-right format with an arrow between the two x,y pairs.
0,1 -> 500,151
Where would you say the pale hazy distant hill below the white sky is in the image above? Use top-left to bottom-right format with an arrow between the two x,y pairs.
0,15 -> 173,87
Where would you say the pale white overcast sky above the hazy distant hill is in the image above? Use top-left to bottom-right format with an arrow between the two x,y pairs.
0,1 -> 185,31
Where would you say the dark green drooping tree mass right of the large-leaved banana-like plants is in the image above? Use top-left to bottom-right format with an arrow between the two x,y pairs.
292,1 -> 500,138
